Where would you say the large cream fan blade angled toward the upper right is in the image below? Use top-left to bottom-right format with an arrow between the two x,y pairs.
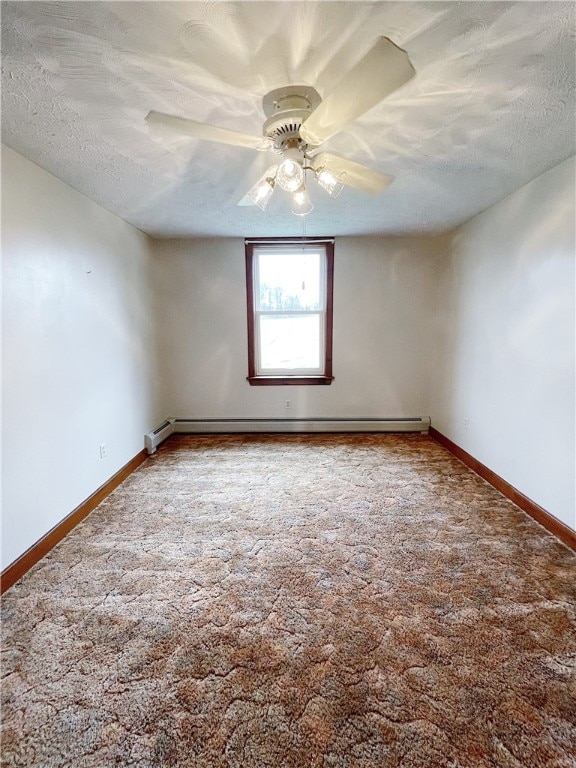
300,37 -> 416,146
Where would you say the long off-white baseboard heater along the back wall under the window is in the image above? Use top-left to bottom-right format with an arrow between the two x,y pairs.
145,417 -> 430,454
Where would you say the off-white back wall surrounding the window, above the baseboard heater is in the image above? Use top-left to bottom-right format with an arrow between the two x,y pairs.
154,233 -> 443,418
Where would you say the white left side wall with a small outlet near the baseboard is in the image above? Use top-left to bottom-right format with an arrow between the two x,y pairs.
2,147 -> 163,567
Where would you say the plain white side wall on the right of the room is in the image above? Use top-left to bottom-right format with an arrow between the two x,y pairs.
431,158 -> 576,528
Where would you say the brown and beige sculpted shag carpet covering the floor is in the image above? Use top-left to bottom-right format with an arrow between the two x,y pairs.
2,435 -> 576,768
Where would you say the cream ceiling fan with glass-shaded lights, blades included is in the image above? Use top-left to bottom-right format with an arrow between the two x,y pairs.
146,37 -> 415,216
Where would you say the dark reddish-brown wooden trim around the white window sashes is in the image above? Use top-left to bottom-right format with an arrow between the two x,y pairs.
244,237 -> 334,386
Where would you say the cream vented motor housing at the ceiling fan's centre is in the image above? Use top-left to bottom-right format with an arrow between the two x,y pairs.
262,85 -> 322,153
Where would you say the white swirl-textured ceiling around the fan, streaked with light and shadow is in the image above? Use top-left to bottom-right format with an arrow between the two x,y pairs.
2,0 -> 575,237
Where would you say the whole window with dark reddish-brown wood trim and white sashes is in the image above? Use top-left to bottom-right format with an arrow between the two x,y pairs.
246,238 -> 334,385
